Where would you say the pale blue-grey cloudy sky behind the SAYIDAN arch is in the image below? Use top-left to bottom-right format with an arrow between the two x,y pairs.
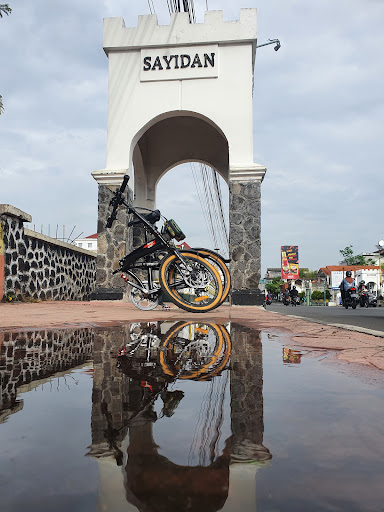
0,0 -> 384,272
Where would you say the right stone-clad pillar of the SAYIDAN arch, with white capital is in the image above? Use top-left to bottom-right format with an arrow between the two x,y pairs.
229,166 -> 266,305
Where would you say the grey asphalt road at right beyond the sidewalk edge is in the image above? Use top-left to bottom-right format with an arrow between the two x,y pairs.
267,303 -> 384,336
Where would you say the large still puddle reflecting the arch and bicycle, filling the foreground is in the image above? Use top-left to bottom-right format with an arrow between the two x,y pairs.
0,321 -> 384,512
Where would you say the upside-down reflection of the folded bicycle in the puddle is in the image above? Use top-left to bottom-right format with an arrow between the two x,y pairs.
117,322 -> 231,423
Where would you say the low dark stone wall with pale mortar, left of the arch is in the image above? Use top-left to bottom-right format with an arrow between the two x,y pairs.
0,205 -> 96,300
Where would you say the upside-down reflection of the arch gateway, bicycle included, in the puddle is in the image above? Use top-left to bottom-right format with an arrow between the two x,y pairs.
89,322 -> 271,512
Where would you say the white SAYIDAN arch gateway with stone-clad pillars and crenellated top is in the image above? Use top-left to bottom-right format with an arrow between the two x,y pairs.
92,9 -> 266,304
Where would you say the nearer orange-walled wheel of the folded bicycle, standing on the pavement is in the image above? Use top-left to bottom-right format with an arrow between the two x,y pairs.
159,252 -> 223,313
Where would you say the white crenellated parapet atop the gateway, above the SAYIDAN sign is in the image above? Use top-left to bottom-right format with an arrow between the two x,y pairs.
103,9 -> 257,54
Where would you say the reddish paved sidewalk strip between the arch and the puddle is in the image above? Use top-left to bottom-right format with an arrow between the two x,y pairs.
0,301 -> 384,375
